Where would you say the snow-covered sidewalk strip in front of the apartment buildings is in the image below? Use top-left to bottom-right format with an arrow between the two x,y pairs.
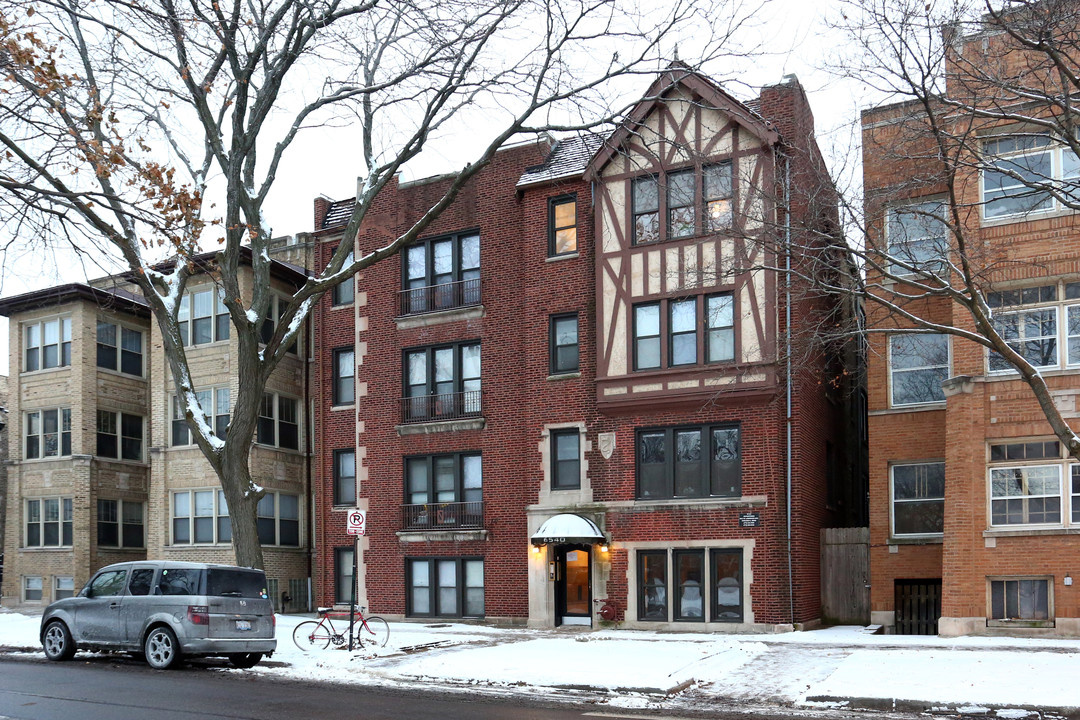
0,612 -> 1080,720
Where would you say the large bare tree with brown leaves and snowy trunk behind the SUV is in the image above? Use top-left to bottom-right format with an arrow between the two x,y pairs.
0,0 -> 752,567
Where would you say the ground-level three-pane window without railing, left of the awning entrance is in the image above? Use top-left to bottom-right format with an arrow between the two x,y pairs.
405,558 -> 484,617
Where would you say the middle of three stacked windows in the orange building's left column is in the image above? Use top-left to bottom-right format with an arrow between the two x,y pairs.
889,332 -> 949,407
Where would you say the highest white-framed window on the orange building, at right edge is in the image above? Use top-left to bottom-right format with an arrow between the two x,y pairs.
982,133 -> 1080,220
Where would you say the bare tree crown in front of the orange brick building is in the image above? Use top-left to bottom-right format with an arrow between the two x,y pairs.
807,0 -> 1080,459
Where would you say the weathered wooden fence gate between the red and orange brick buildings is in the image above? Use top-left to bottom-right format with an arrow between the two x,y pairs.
821,528 -> 870,625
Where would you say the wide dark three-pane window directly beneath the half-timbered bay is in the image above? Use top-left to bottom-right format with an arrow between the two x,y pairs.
637,425 -> 742,500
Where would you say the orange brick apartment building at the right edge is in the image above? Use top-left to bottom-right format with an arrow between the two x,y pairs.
862,9 -> 1080,636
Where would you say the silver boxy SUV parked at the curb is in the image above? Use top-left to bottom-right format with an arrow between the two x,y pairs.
41,560 -> 278,669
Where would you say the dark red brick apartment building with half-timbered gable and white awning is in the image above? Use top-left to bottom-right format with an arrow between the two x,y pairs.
312,68 -> 861,629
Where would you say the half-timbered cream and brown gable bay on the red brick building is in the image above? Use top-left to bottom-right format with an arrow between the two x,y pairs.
586,70 -> 779,406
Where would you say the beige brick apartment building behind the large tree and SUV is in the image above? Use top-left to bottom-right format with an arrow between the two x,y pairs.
0,246 -> 311,609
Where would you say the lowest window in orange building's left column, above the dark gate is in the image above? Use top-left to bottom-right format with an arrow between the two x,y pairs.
889,462 -> 945,536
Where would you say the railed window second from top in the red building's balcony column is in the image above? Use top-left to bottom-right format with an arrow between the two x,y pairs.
405,342 -> 481,421
